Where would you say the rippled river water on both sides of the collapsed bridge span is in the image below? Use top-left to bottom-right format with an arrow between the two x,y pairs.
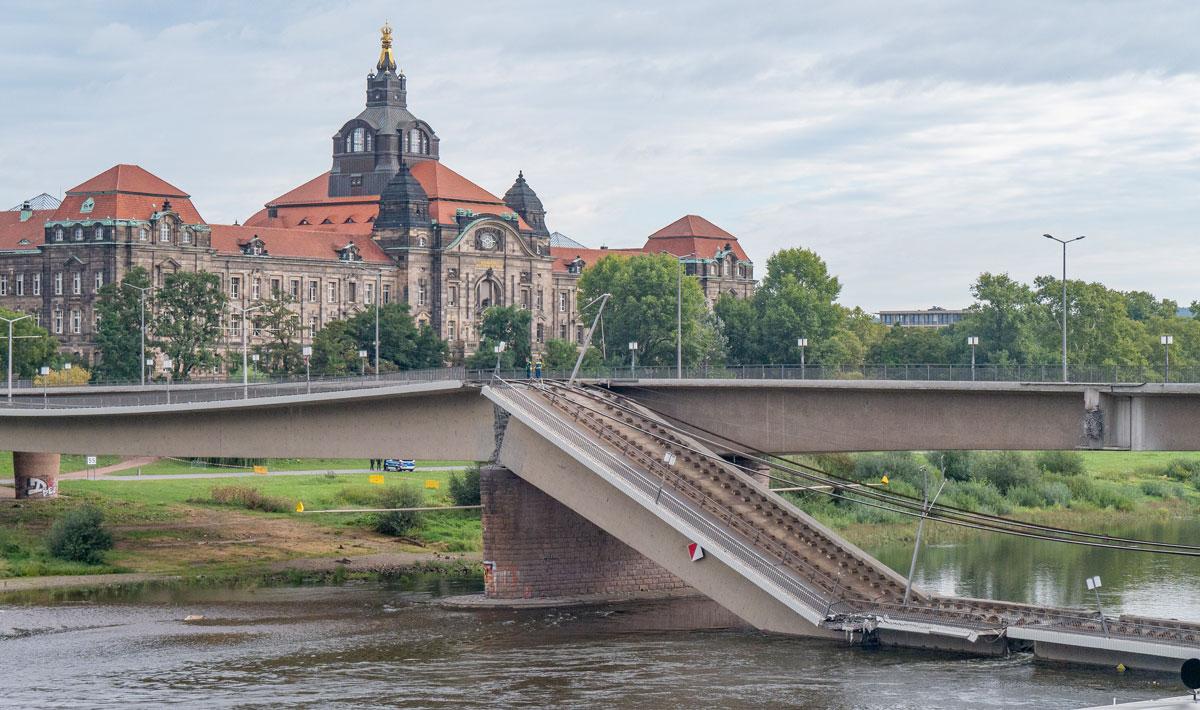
0,524 -> 1200,709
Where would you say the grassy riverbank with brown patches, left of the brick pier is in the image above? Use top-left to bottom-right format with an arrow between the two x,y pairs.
0,471 -> 481,577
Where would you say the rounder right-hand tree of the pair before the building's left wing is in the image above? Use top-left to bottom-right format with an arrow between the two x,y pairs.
154,271 -> 228,379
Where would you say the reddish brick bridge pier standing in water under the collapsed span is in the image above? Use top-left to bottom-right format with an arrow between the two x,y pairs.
480,467 -> 689,598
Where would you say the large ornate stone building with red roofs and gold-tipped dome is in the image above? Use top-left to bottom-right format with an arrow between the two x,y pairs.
0,26 -> 755,360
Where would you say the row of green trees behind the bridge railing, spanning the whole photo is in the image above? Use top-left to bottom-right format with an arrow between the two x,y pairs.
0,248 -> 1200,380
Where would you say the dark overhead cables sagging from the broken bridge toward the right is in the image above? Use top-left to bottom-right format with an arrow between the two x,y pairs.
544,385 -> 1200,556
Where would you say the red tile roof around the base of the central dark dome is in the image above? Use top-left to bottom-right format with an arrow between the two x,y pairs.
246,161 -> 529,234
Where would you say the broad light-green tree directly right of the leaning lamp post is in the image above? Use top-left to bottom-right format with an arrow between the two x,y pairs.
578,254 -> 705,365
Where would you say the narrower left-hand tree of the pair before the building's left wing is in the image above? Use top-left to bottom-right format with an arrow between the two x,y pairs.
91,266 -> 154,380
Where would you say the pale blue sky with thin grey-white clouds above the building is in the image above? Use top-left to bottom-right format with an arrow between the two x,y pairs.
0,0 -> 1200,312
